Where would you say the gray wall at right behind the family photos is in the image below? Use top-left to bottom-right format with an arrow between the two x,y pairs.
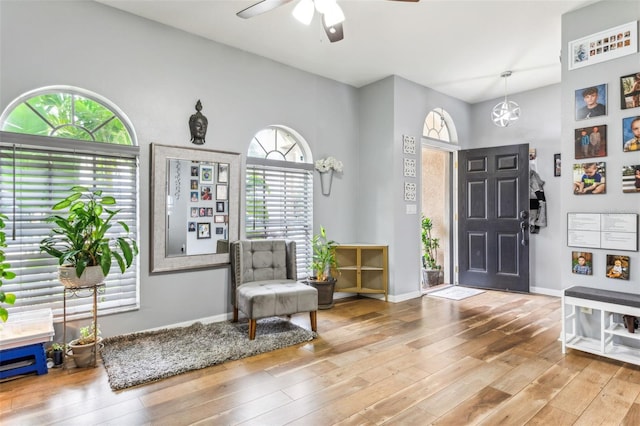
560,1 -> 640,293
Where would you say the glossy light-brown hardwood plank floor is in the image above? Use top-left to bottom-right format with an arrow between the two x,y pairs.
0,292 -> 640,426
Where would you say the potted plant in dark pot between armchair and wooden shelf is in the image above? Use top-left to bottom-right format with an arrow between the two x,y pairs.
308,226 -> 338,309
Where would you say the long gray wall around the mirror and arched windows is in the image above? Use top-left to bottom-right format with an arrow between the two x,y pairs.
0,1 -> 359,336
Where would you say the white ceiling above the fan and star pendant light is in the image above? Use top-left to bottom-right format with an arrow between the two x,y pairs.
97,0 -> 594,103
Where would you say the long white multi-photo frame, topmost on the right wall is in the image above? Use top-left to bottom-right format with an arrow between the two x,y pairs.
567,21 -> 638,71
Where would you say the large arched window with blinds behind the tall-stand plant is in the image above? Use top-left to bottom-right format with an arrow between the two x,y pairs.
0,86 -> 139,319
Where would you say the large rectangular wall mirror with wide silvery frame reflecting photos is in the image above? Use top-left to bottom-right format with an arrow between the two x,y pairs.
150,144 -> 240,272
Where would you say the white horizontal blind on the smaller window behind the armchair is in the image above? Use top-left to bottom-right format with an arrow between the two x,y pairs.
245,159 -> 313,279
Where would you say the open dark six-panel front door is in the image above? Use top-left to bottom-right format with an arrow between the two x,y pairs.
458,144 -> 529,293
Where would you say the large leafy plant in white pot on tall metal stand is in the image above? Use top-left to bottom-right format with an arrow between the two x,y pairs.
40,186 -> 138,287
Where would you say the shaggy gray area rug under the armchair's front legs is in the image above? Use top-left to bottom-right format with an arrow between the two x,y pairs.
101,318 -> 317,390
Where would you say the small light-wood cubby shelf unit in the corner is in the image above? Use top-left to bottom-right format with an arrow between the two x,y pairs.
335,244 -> 389,302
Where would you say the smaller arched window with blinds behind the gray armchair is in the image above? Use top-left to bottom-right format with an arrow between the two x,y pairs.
245,126 -> 313,278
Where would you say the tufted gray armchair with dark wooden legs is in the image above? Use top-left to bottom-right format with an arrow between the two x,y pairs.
230,240 -> 318,340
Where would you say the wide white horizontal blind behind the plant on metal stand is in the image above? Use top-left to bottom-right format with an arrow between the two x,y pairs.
0,142 -> 139,319
